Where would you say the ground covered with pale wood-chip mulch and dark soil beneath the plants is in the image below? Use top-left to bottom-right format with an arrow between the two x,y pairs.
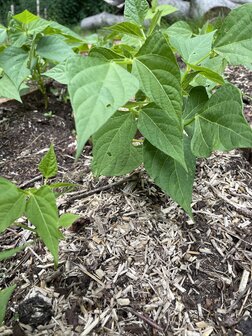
0,68 -> 252,336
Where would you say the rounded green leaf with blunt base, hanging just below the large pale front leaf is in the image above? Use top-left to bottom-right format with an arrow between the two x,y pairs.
92,111 -> 143,176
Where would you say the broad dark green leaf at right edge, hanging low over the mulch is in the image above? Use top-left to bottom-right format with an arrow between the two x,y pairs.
192,84 -> 252,157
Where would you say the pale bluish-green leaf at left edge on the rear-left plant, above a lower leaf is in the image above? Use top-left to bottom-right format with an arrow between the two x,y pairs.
0,46 -> 30,89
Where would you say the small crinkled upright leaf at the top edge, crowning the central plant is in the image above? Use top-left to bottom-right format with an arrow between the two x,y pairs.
124,0 -> 149,26
